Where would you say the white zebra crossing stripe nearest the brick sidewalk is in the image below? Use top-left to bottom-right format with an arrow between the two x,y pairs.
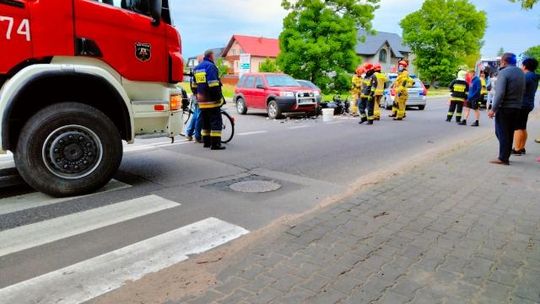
0,218 -> 249,304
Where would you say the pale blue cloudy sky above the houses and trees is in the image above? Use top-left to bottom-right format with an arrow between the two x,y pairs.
174,0 -> 540,58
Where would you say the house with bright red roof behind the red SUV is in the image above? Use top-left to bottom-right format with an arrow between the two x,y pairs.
222,35 -> 280,75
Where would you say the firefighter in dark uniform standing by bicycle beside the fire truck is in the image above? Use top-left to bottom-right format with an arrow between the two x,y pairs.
192,57 -> 225,150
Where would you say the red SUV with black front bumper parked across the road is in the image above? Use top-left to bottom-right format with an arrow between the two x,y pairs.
234,73 -> 320,119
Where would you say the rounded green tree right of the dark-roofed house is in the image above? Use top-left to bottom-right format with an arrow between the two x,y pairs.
400,0 -> 487,84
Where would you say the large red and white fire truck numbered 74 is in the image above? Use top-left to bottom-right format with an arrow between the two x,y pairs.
0,0 -> 183,196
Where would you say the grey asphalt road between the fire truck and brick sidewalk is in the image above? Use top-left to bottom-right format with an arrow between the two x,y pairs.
0,98 -> 495,301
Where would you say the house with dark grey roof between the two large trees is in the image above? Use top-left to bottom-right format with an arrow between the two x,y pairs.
356,30 -> 415,73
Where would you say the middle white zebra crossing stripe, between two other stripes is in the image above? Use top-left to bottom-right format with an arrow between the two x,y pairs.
0,195 -> 180,256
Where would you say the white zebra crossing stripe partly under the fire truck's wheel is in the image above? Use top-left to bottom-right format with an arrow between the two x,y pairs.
0,179 -> 131,215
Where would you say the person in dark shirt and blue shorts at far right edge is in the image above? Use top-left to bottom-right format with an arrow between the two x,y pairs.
512,58 -> 540,155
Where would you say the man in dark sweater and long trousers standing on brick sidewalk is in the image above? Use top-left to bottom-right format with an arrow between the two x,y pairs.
488,53 -> 525,165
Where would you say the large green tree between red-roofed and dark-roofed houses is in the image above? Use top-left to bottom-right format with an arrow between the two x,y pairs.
278,0 -> 379,92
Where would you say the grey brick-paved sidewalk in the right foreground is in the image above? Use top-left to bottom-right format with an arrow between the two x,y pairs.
173,134 -> 540,304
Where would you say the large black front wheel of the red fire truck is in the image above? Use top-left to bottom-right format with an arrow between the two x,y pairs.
15,102 -> 122,197
